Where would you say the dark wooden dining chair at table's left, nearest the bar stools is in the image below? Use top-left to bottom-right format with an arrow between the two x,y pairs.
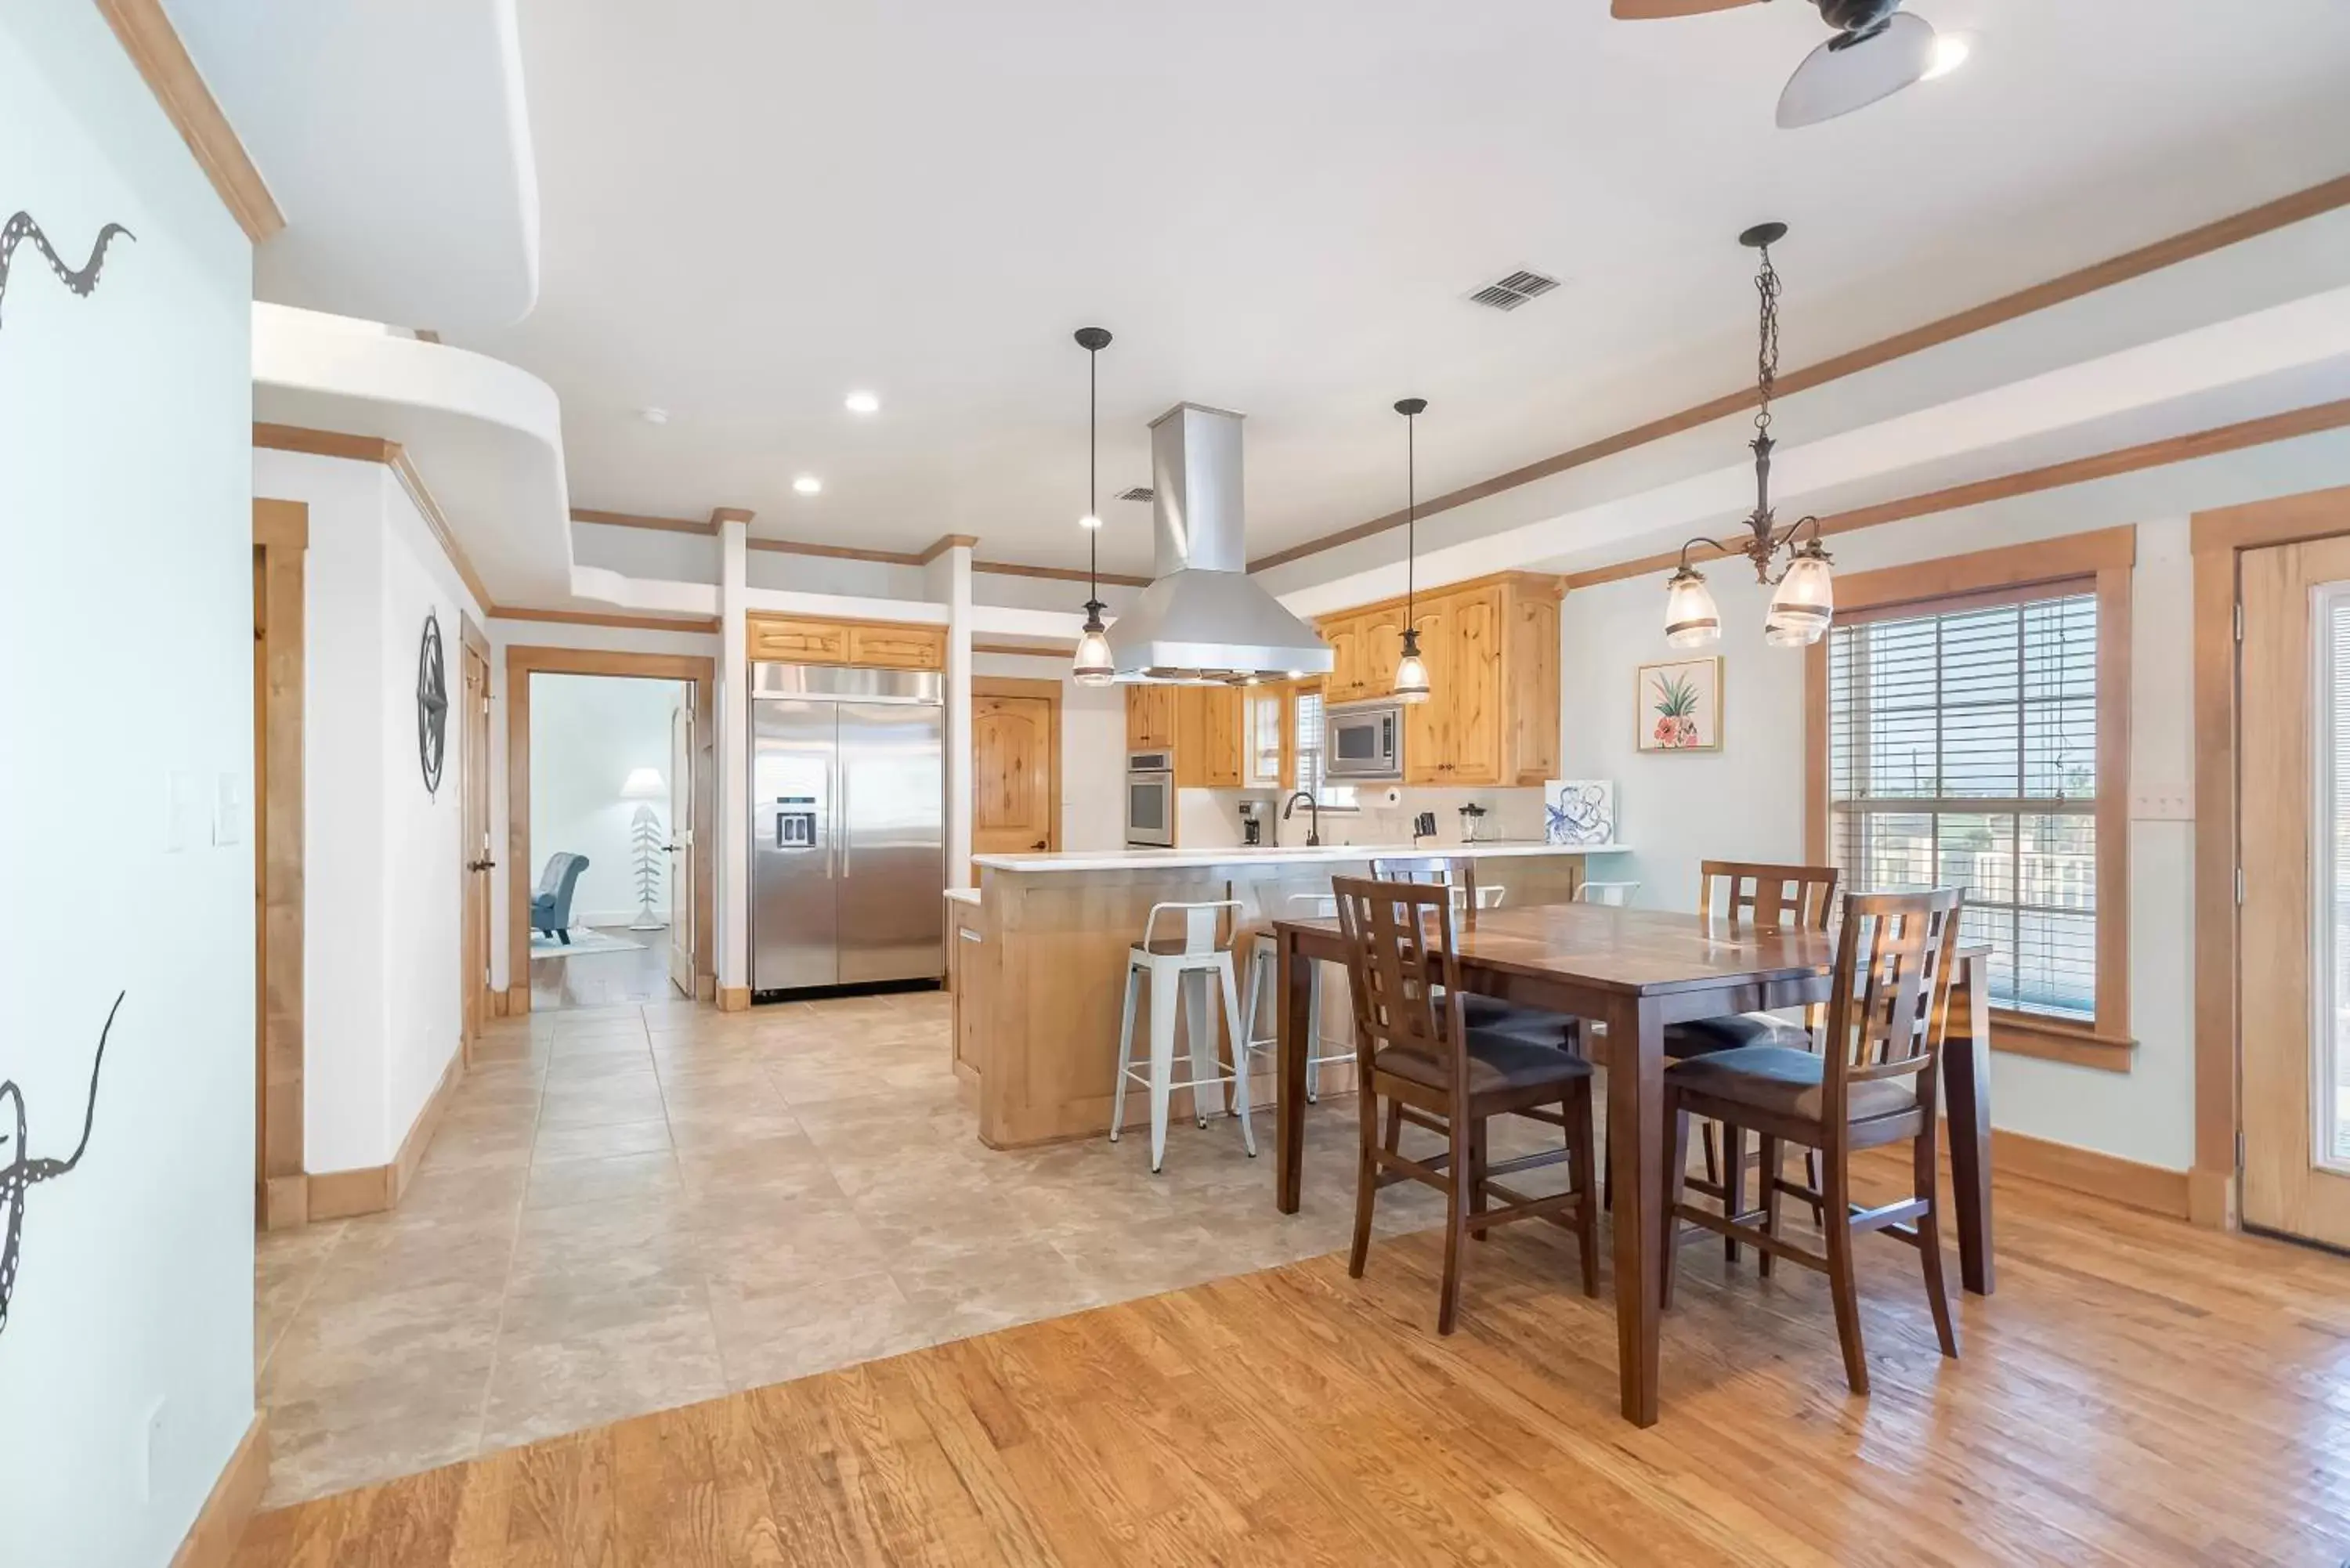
1332,877 -> 1600,1333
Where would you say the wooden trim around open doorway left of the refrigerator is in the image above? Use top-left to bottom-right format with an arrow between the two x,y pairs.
505,644 -> 719,1013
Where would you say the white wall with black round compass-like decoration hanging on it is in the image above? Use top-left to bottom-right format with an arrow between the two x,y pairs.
251,451 -> 484,1171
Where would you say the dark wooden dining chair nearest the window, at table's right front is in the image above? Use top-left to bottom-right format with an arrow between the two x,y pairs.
1659,889 -> 1962,1394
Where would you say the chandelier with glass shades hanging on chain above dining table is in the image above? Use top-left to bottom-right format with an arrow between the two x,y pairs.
1664,223 -> 1835,649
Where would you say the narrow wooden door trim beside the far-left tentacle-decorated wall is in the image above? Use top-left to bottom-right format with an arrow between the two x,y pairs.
254,498 -> 310,1230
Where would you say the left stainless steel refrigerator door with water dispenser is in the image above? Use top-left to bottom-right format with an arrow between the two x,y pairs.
750,695 -> 841,990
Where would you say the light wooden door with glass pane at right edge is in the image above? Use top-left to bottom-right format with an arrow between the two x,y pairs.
2237,531 -> 2350,1246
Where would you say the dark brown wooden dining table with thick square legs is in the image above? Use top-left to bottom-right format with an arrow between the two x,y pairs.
1274,903 -> 1993,1427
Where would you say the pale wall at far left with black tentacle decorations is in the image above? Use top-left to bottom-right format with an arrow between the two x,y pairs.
0,5 -> 254,1568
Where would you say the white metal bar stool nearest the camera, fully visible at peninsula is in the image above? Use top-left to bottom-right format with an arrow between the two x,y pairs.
1109,898 -> 1257,1171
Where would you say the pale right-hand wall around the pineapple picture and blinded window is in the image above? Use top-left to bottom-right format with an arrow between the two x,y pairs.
1560,442 -> 2312,1169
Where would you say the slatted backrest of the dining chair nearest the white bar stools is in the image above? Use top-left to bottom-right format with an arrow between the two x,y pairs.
1330,877 -> 1469,1093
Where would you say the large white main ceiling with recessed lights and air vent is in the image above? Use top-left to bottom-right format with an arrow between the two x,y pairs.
451,0 -> 2350,571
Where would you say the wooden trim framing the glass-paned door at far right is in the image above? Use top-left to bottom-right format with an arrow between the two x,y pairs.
2188,486 -> 2350,1230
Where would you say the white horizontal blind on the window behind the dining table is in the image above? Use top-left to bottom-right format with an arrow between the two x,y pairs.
1828,590 -> 2096,1023
